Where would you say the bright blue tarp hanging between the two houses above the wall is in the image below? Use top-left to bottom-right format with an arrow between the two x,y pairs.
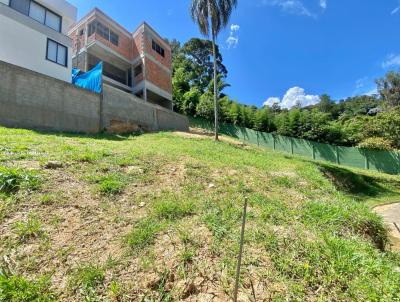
72,62 -> 103,93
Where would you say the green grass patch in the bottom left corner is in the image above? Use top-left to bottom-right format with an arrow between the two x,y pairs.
0,270 -> 56,302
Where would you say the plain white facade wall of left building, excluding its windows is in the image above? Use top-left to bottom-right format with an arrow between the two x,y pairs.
0,12 -> 72,82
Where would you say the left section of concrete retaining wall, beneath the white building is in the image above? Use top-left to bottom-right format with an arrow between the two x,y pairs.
0,61 -> 100,133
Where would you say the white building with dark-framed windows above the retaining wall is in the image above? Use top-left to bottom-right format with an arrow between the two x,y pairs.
0,0 -> 77,82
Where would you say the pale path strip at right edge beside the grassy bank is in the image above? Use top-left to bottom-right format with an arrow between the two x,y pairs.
374,203 -> 400,251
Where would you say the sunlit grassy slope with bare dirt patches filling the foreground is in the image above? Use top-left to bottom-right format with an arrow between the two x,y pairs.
0,128 -> 400,301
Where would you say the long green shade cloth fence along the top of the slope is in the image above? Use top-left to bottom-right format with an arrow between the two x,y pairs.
188,117 -> 400,174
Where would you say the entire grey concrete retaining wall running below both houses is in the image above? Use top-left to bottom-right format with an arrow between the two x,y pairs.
0,61 -> 189,133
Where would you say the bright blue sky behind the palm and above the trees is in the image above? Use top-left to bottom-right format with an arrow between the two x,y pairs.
68,0 -> 400,108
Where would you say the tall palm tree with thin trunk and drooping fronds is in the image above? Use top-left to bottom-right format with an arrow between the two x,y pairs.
190,0 -> 237,140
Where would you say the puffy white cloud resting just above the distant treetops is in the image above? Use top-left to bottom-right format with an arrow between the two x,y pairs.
264,87 -> 320,109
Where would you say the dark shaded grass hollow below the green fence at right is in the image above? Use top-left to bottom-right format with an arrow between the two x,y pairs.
318,164 -> 400,201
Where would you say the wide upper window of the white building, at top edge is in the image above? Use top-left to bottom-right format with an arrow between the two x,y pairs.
10,0 -> 62,32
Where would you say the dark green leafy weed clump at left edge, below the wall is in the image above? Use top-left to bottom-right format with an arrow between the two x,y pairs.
0,166 -> 41,194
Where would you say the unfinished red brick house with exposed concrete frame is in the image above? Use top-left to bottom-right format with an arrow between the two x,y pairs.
69,8 -> 172,109
